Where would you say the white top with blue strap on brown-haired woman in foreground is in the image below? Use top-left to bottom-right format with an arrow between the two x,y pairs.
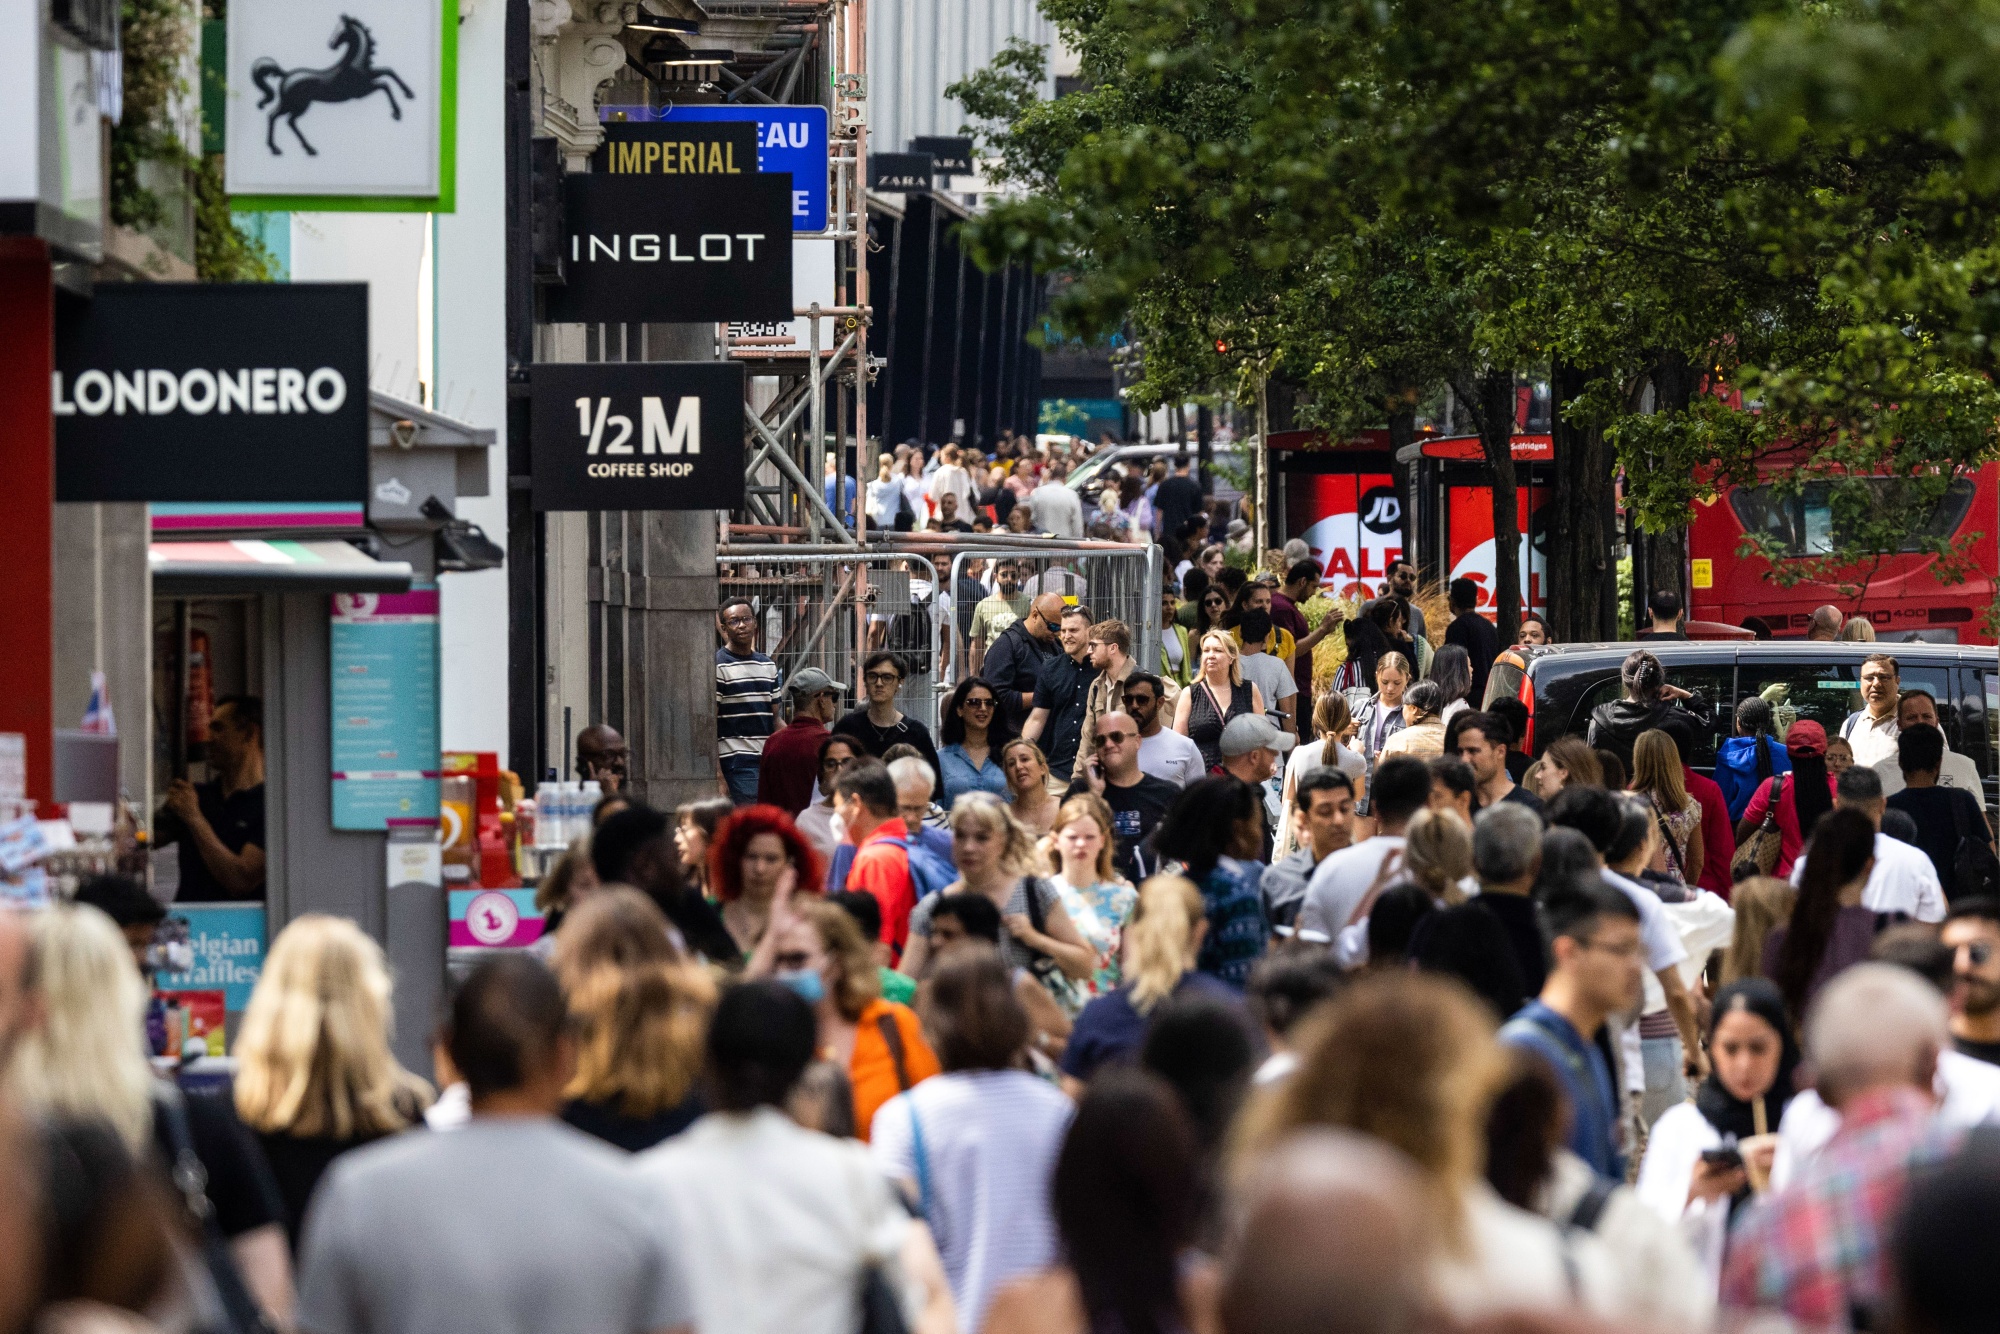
868,1070 -> 1076,1334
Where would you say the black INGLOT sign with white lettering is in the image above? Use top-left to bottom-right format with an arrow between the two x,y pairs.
544,172 -> 792,324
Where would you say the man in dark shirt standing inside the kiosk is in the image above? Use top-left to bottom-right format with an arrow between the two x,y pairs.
152,694 -> 266,904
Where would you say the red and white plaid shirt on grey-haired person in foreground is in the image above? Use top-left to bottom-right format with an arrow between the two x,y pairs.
1722,1088 -> 1956,1328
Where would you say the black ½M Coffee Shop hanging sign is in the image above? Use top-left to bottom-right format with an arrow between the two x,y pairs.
530,360 -> 748,510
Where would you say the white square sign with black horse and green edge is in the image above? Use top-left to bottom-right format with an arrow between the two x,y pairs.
224,0 -> 458,212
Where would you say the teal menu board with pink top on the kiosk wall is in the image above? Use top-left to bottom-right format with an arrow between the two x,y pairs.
330,588 -> 444,830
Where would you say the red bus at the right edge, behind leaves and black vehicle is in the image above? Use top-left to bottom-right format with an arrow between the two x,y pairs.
1688,464 -> 2000,644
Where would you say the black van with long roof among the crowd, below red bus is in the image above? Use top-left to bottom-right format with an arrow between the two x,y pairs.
1486,640 -> 2000,808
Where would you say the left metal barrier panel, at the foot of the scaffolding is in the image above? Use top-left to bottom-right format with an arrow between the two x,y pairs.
716,546 -> 944,738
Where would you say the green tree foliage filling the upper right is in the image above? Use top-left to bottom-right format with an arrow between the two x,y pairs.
954,0 -> 2000,610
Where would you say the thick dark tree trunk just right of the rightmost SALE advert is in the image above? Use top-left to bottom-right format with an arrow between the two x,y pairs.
1542,358 -> 1618,644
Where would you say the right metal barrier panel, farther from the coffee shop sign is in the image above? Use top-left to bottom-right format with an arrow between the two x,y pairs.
946,542 -> 1160,686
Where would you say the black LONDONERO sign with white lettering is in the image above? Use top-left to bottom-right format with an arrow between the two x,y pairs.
52,282 -> 368,504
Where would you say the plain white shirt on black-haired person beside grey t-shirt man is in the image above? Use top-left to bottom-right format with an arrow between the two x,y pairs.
632,1106 -> 910,1334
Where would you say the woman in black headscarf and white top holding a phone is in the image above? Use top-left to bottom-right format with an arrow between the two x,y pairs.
1638,978 -> 1798,1288
